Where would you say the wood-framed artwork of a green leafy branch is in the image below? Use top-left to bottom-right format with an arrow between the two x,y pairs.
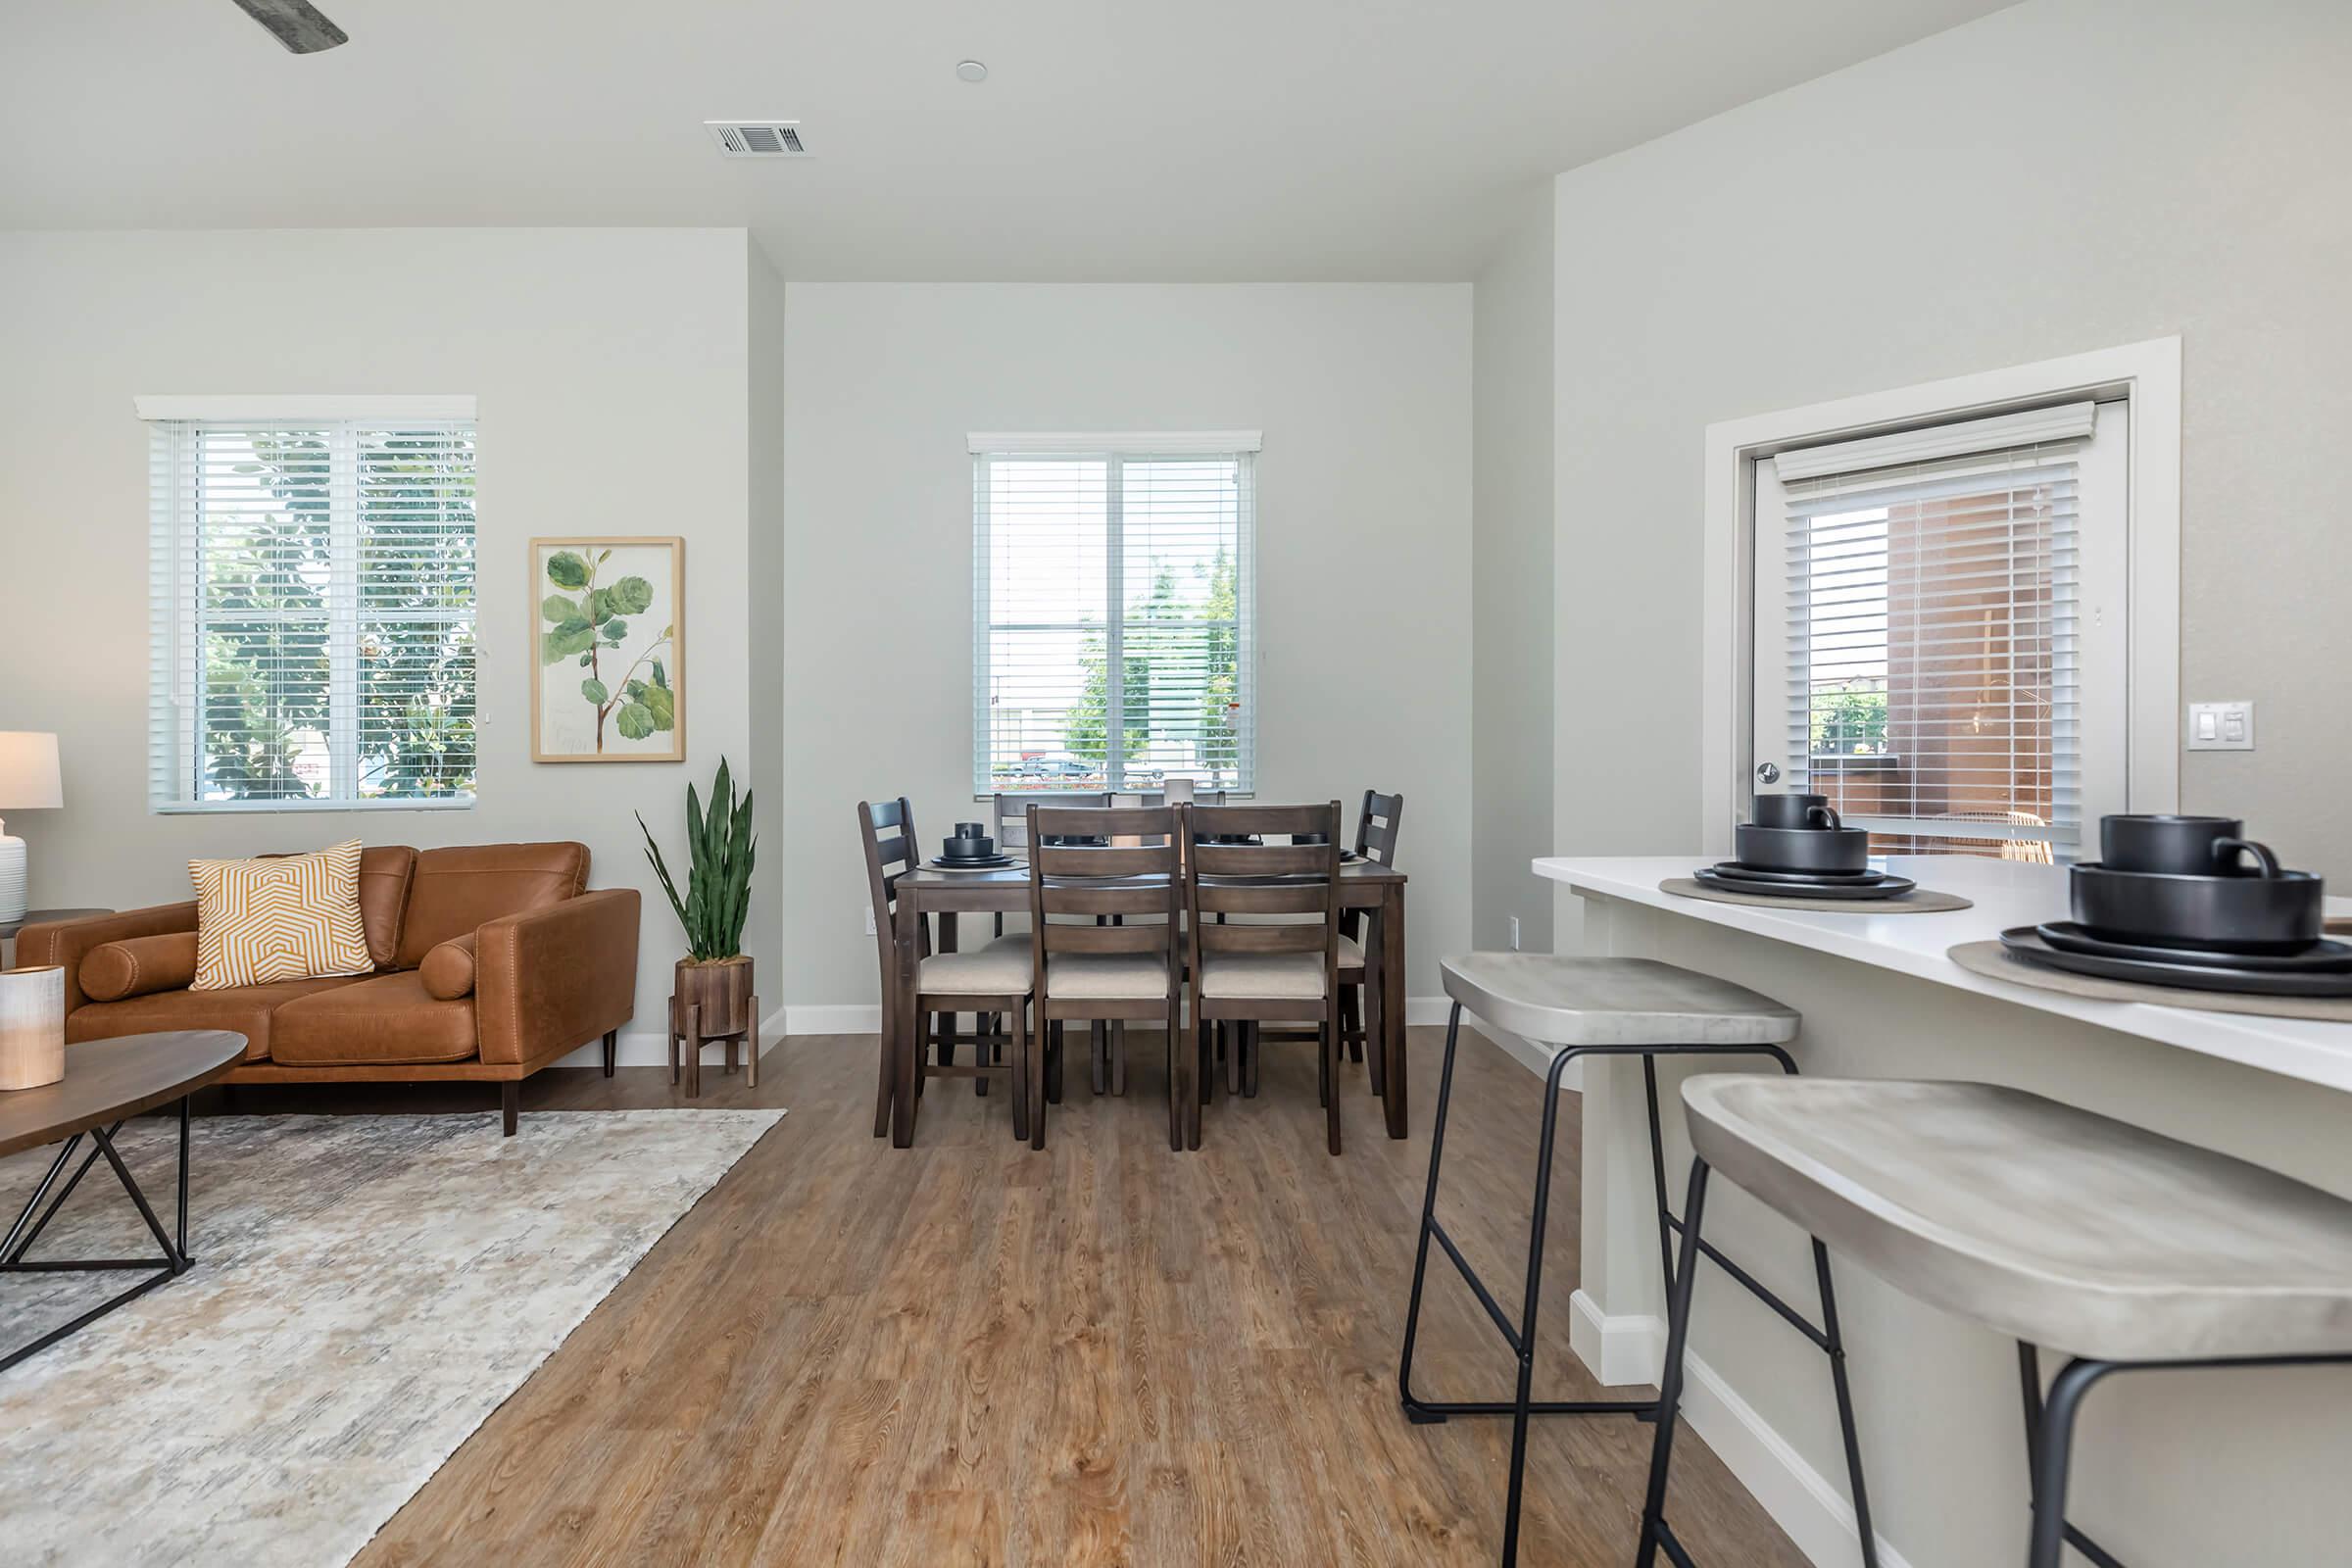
531,538 -> 687,761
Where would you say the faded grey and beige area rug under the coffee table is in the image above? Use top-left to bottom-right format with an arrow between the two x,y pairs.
0,1109 -> 783,1568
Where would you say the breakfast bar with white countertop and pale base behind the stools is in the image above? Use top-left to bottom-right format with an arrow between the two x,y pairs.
1524,854 -> 2352,1568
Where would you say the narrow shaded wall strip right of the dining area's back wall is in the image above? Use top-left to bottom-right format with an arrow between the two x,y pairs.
1470,181 -> 1552,953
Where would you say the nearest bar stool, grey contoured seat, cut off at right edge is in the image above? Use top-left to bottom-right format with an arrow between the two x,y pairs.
1635,1074 -> 2352,1568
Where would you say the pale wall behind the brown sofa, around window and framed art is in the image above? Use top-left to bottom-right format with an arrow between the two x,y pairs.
0,228 -> 761,1060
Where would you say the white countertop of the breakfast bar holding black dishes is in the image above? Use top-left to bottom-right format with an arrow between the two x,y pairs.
1536,856 -> 2352,1089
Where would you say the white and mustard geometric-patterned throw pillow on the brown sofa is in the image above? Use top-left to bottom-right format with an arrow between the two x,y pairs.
188,839 -> 376,992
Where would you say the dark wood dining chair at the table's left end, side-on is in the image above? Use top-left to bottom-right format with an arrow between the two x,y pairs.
858,795 -> 1030,1138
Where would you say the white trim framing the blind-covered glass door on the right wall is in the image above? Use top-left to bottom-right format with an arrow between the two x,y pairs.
1698,336 -> 2180,854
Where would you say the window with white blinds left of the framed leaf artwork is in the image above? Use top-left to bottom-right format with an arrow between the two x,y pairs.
148,418 -> 475,811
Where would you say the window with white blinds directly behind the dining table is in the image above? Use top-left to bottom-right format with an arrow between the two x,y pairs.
971,432 -> 1256,795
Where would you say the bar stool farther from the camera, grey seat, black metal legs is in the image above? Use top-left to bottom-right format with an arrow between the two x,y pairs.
1397,953 -> 1877,1568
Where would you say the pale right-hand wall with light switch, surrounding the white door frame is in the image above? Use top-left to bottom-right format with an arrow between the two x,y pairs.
1554,0 -> 2352,921
